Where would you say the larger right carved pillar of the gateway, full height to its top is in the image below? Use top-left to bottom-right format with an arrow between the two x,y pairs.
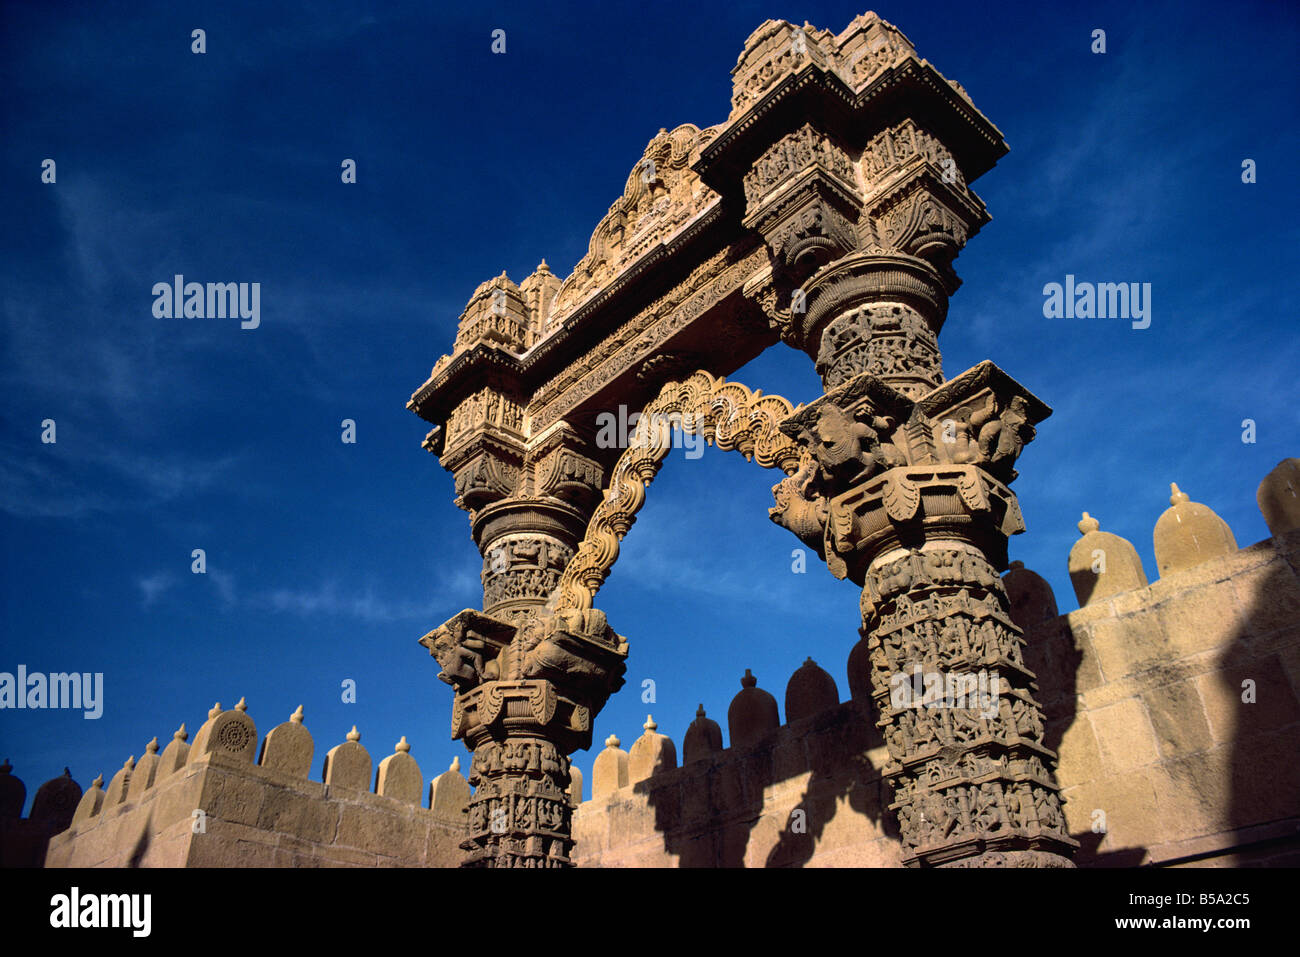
699,14 -> 1074,866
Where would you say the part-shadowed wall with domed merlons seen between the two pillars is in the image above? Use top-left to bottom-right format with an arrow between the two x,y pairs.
579,659 -> 898,867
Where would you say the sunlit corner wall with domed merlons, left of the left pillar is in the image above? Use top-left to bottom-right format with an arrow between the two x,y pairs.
34,709 -> 471,867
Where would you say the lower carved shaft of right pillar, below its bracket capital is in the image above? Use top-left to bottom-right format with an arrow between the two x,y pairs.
862,486 -> 1076,866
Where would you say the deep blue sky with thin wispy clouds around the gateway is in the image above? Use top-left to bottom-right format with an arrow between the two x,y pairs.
0,0 -> 1300,802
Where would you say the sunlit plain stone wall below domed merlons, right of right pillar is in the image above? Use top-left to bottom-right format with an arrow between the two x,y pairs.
1026,532 -> 1300,866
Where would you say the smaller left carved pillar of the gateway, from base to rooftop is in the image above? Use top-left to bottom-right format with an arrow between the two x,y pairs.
408,263 -> 627,867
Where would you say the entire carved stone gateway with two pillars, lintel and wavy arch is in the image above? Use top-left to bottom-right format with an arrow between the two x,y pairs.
408,13 -> 1073,866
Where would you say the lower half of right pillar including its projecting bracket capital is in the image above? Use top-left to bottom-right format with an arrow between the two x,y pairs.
772,363 -> 1075,866
